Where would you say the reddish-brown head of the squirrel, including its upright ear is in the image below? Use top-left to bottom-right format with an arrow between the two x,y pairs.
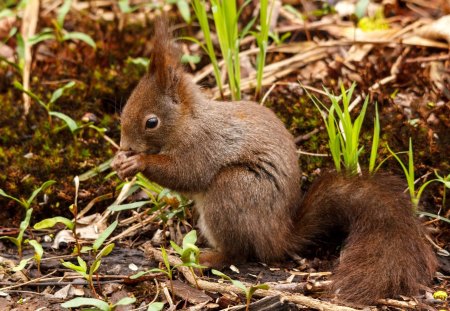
120,20 -> 195,154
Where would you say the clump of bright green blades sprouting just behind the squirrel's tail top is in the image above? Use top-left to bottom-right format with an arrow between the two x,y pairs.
308,83 -> 380,174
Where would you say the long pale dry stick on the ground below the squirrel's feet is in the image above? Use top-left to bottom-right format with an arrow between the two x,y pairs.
143,243 -> 357,311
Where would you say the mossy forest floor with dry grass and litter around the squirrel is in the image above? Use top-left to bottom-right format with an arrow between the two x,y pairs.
0,0 -> 450,310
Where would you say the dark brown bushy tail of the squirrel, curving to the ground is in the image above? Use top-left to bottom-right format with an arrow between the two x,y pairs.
298,173 -> 437,304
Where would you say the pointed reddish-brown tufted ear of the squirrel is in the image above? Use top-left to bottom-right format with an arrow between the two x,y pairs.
148,16 -> 183,90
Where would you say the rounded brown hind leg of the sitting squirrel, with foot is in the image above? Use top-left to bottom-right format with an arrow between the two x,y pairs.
192,166 -> 293,264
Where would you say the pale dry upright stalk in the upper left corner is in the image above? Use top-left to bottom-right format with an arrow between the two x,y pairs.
20,0 -> 39,116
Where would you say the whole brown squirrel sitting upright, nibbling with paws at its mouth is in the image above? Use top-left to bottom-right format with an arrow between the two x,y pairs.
112,22 -> 437,303
